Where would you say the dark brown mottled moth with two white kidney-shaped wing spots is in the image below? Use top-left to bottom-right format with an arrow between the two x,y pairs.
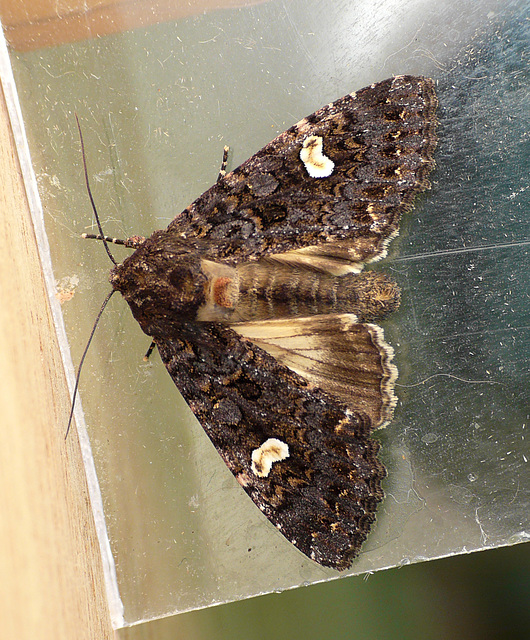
83,75 -> 437,570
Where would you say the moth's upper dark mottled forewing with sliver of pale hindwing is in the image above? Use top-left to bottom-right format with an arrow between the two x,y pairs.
168,76 -> 437,273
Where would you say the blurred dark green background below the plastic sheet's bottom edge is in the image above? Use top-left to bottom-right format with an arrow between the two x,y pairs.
119,544 -> 530,640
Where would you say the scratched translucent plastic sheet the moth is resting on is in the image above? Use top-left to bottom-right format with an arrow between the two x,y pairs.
5,0 -> 530,624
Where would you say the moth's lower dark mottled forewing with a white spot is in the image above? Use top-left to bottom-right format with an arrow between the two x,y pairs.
157,323 -> 385,570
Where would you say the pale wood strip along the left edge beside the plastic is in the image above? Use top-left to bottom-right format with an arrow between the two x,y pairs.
0,74 -> 113,640
